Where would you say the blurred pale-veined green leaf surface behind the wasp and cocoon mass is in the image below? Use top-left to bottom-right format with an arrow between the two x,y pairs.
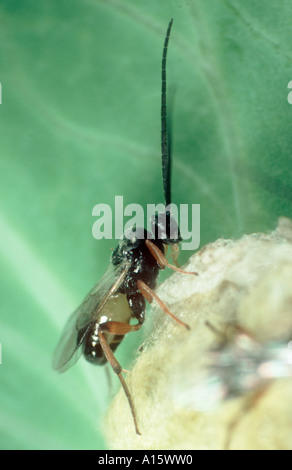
0,0 -> 292,449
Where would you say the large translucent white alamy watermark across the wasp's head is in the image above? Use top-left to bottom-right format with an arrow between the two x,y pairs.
92,196 -> 200,250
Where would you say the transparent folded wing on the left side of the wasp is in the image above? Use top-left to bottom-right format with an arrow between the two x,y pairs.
53,261 -> 130,372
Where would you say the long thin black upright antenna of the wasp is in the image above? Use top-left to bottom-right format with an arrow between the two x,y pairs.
161,19 -> 173,206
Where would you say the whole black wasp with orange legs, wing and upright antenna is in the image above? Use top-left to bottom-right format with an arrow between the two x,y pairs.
53,20 -> 196,434
